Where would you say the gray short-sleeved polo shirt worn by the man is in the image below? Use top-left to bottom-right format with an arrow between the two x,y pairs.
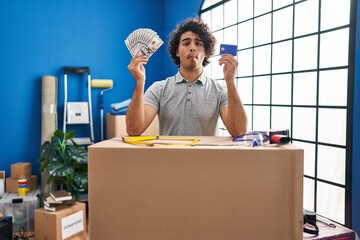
144,72 -> 228,136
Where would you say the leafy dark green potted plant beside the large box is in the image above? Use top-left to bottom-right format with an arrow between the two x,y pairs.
39,130 -> 88,200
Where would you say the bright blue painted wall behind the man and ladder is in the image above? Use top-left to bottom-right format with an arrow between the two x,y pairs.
0,0 -> 360,232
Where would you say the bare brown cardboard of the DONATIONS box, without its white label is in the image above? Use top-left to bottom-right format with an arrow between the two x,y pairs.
34,202 -> 86,240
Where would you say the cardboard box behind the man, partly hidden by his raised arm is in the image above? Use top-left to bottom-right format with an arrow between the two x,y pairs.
106,113 -> 159,139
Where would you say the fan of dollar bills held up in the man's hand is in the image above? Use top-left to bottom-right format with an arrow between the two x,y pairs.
125,28 -> 164,57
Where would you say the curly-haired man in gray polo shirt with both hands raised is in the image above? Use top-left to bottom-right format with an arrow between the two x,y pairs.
126,18 -> 247,136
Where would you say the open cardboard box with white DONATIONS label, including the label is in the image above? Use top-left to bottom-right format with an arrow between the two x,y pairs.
34,202 -> 86,240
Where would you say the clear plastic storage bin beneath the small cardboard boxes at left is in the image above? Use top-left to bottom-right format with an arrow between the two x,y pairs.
0,189 -> 41,232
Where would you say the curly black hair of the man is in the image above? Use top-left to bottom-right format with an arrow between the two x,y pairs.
168,17 -> 216,67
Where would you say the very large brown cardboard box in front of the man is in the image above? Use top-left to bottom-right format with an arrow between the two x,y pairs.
88,137 -> 303,240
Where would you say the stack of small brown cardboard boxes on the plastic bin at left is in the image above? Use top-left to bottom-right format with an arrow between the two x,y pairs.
5,162 -> 37,193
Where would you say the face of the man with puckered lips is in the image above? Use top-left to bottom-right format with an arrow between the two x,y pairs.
176,31 -> 205,70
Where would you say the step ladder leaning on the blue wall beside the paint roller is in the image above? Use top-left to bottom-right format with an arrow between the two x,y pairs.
63,66 -> 94,145
